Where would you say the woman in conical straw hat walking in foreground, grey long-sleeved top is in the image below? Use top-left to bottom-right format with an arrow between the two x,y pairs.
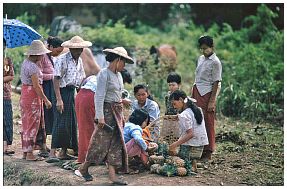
75,47 -> 134,185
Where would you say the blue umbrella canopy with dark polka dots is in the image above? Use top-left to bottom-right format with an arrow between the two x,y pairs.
3,19 -> 42,48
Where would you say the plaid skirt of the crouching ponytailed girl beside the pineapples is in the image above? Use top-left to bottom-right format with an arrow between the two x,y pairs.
178,145 -> 204,160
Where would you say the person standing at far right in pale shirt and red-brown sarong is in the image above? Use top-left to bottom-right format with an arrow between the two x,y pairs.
192,36 -> 222,160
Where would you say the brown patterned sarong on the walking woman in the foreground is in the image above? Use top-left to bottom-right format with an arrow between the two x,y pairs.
86,103 -> 128,171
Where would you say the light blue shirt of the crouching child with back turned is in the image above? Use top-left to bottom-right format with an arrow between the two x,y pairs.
124,122 -> 147,150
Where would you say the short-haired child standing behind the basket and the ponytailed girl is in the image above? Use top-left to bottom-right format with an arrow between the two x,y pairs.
165,72 -> 181,115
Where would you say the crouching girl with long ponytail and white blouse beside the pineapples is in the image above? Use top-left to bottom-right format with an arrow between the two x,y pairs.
169,90 -> 208,172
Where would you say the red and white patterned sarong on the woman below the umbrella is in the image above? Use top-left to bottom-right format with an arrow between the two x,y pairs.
20,85 -> 46,152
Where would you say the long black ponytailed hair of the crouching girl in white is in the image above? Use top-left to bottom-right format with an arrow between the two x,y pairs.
169,90 -> 203,124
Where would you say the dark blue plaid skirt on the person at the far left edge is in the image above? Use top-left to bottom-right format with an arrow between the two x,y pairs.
3,99 -> 13,145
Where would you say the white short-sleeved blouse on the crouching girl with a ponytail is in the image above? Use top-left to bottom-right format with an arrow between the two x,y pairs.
178,108 -> 208,146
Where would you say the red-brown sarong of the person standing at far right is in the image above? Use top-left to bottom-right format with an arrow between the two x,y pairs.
192,85 -> 215,152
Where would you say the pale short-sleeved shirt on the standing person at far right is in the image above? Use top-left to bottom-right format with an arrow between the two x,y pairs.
194,53 -> 222,96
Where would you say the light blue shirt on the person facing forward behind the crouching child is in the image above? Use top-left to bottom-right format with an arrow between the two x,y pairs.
132,98 -> 160,121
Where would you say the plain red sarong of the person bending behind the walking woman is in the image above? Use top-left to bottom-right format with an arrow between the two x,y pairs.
75,89 -> 95,163
